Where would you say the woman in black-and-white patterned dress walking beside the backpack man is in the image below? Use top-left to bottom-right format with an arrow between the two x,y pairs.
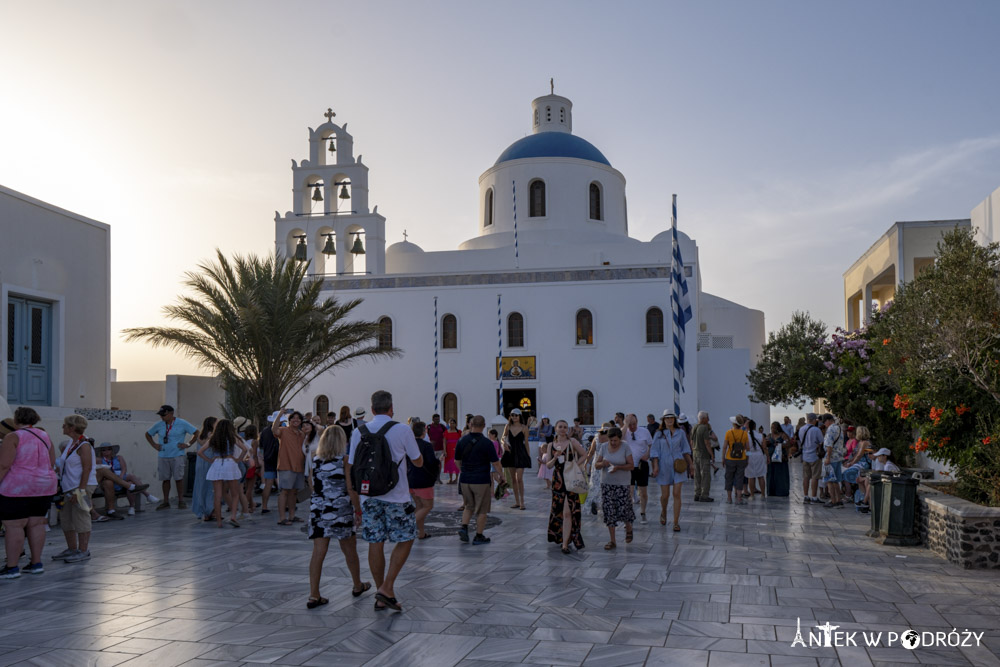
306,425 -> 372,609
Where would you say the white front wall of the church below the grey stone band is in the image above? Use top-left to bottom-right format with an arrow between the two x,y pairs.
296,280 -> 699,420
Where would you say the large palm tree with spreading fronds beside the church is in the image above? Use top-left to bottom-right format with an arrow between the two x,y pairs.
122,249 -> 399,424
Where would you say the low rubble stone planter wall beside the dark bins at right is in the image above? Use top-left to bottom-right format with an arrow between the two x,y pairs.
916,484 -> 1000,569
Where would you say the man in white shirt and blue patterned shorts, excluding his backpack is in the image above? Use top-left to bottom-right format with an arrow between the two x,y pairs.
344,390 -> 424,611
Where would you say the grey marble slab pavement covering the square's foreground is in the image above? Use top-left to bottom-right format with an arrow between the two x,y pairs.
0,464 -> 1000,667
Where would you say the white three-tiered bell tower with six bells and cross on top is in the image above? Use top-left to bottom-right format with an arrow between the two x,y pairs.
274,109 -> 385,277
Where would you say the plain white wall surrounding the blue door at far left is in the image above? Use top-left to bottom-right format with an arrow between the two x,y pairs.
0,186 -> 111,408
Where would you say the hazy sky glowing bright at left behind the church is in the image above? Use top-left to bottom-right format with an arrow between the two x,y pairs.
0,0 -> 1000,380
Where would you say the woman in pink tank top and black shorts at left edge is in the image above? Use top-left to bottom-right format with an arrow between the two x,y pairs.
0,407 -> 58,579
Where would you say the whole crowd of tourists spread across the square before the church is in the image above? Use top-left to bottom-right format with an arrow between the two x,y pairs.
0,391 -> 898,610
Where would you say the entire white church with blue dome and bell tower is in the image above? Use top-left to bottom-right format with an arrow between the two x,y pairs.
275,94 -> 769,427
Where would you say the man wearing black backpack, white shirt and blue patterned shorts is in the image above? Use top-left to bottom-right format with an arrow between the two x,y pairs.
345,390 -> 424,611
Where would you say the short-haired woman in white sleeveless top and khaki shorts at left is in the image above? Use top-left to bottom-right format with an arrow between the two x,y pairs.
52,415 -> 97,563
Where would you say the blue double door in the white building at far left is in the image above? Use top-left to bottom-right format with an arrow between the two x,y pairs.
7,297 -> 52,405
